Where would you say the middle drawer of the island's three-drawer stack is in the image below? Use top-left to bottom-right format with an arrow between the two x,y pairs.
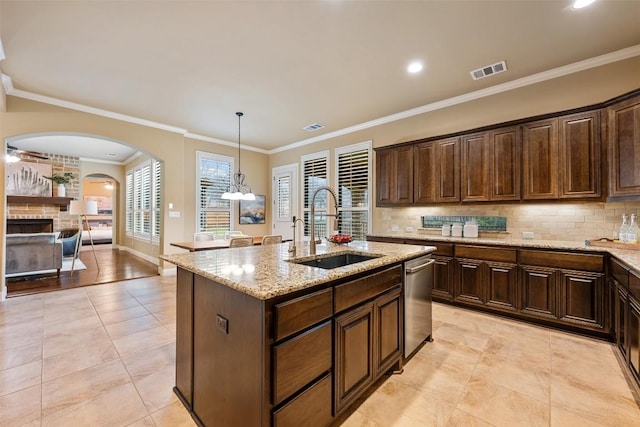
273,321 -> 332,405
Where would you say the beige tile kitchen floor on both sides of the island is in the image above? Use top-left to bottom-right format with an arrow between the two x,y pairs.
0,277 -> 640,427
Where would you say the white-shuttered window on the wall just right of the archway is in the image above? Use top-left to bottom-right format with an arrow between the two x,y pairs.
125,159 -> 162,245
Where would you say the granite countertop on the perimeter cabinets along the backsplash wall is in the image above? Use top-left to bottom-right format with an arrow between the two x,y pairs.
370,233 -> 640,272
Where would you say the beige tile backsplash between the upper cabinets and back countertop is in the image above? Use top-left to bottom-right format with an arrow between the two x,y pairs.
372,202 -> 640,241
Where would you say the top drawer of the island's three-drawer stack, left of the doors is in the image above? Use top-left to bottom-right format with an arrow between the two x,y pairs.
275,288 -> 333,341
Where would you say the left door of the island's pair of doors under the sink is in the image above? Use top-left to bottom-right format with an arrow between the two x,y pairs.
334,302 -> 374,413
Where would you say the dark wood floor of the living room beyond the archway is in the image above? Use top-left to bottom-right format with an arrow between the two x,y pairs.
6,245 -> 158,298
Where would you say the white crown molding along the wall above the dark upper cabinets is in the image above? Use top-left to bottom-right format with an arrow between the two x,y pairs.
269,45 -> 640,154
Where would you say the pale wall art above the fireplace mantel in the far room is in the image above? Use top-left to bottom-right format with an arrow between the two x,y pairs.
5,162 -> 53,197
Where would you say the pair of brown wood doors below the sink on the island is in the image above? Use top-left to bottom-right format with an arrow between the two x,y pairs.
334,287 -> 403,415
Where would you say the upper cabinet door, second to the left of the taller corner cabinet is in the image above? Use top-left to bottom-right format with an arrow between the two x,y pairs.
522,119 -> 559,200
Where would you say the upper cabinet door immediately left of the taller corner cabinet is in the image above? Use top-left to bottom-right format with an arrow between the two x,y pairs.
560,111 -> 602,199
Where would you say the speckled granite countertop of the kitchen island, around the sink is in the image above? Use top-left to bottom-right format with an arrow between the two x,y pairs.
160,241 -> 436,300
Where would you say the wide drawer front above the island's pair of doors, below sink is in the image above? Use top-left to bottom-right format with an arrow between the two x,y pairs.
334,265 -> 402,313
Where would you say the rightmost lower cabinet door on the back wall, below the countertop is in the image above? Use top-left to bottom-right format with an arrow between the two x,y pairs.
560,270 -> 604,329
